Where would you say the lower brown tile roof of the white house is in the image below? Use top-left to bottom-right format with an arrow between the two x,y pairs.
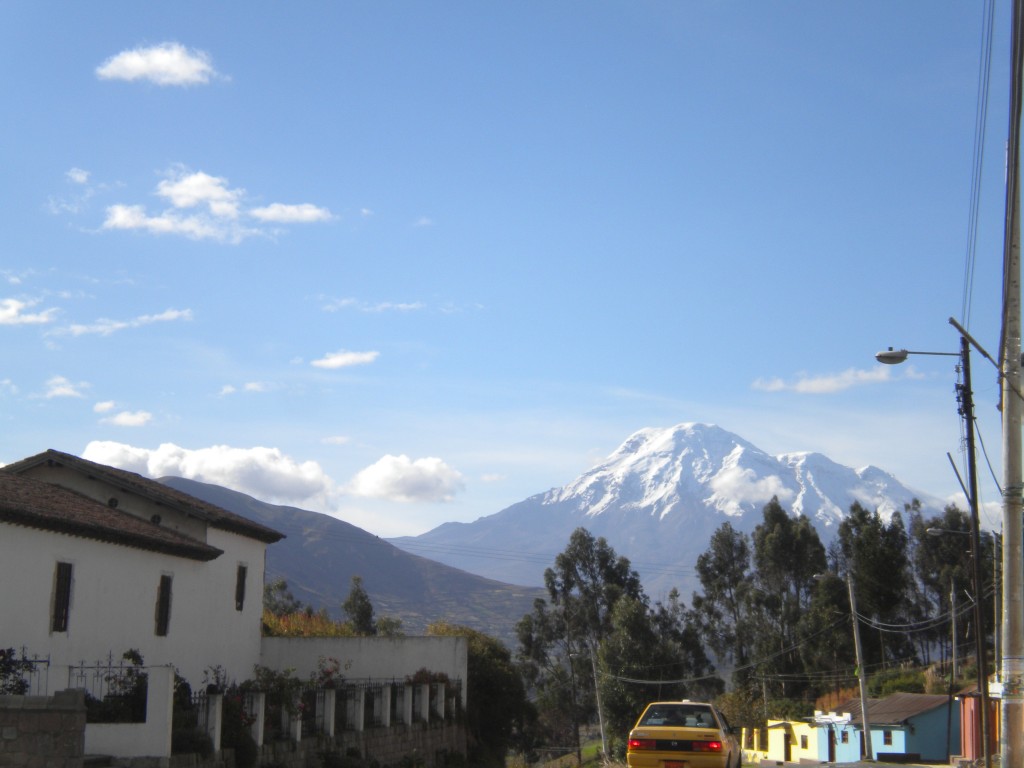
0,472 -> 223,560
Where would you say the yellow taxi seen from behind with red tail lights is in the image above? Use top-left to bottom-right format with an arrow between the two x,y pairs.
626,700 -> 743,768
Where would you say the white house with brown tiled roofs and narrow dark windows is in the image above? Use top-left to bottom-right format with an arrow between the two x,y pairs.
0,451 -> 283,690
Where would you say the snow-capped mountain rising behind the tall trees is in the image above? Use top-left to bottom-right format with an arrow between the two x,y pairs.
391,424 -> 943,600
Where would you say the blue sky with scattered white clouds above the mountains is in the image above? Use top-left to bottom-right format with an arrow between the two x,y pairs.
0,0 -> 1009,536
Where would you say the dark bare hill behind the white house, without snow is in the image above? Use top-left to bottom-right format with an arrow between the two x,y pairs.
160,477 -> 544,647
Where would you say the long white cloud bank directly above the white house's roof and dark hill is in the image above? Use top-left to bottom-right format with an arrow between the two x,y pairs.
83,440 -> 335,508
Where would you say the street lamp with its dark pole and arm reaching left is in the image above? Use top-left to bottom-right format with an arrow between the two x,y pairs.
874,331 -> 992,768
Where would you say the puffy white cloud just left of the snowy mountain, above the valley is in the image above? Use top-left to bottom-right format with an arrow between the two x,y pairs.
347,455 -> 465,502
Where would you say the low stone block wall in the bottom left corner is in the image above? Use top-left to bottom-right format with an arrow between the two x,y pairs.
0,690 -> 85,768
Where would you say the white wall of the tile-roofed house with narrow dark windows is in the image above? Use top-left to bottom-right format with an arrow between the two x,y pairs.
0,523 -> 264,690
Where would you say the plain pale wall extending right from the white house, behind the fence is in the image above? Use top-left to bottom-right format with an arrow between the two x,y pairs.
264,637 -> 469,707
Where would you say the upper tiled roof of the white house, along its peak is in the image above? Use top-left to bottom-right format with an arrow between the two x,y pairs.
0,449 -> 285,544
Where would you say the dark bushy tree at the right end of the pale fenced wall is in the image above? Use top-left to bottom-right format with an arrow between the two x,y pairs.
427,622 -> 535,768
